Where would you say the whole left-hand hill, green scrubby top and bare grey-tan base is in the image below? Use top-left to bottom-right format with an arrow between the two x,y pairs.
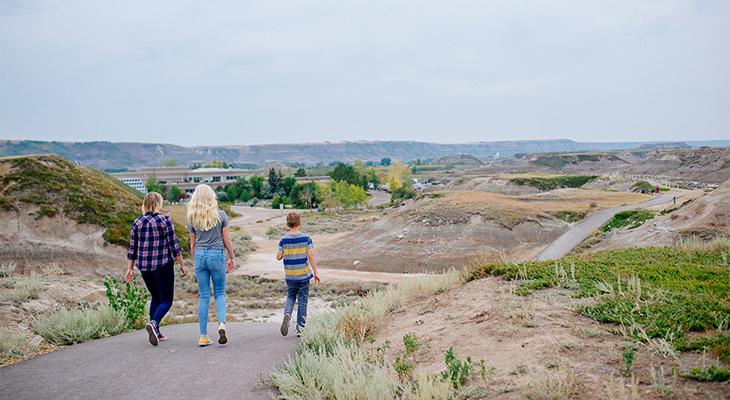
0,155 -> 187,273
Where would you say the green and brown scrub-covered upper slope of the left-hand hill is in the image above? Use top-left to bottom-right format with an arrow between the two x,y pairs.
0,155 -> 188,248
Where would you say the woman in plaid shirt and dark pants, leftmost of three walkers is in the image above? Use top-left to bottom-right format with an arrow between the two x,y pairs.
124,192 -> 187,346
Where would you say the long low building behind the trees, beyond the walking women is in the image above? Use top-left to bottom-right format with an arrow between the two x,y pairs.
111,167 -> 253,193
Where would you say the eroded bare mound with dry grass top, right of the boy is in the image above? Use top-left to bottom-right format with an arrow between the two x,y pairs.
317,189 -> 647,273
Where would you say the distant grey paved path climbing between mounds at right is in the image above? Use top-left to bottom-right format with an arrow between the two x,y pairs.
535,194 -> 675,261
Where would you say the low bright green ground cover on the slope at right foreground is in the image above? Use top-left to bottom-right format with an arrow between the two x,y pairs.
470,241 -> 730,359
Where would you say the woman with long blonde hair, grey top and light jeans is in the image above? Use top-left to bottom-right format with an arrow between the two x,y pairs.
187,185 -> 236,347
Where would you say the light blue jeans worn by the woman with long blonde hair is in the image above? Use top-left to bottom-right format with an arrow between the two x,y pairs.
195,248 -> 226,335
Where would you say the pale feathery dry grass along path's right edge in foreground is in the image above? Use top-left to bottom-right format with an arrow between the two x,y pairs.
272,272 -> 463,399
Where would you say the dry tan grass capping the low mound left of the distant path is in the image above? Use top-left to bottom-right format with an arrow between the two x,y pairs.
409,189 -> 650,227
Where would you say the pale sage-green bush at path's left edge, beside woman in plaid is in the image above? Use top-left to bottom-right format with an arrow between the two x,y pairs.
33,306 -> 127,345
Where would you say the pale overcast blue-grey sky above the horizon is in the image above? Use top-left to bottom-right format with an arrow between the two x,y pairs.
0,0 -> 730,145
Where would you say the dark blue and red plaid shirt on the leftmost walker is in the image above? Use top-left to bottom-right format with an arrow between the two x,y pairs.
127,213 -> 182,271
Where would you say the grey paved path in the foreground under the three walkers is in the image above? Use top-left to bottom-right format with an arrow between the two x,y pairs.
0,323 -> 299,400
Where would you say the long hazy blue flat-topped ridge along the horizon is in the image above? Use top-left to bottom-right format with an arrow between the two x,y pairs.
0,139 -> 730,168
